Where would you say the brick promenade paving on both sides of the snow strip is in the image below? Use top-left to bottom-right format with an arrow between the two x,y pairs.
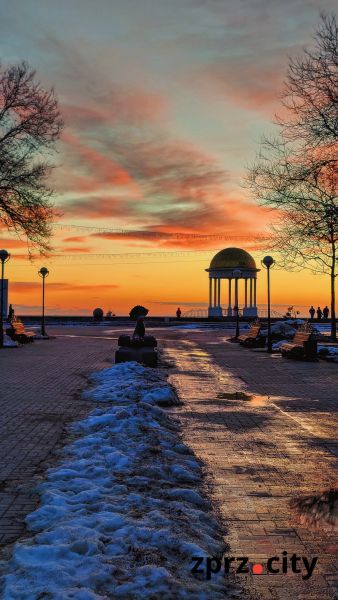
0,327 -> 338,600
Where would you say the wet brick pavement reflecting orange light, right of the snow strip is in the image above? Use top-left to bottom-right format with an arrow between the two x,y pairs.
158,330 -> 338,600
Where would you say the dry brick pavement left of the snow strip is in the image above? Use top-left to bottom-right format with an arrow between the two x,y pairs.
0,330 -> 113,548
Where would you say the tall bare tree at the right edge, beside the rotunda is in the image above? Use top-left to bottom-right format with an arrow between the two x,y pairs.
247,16 -> 338,339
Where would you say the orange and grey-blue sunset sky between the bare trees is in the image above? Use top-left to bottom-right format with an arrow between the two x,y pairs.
0,0 -> 336,315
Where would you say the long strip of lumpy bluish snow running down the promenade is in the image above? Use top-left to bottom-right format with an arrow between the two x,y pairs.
1,363 -> 240,600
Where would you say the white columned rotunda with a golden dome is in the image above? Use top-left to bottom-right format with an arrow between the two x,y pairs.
205,248 -> 260,317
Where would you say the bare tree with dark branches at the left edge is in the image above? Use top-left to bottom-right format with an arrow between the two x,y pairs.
0,62 -> 63,252
